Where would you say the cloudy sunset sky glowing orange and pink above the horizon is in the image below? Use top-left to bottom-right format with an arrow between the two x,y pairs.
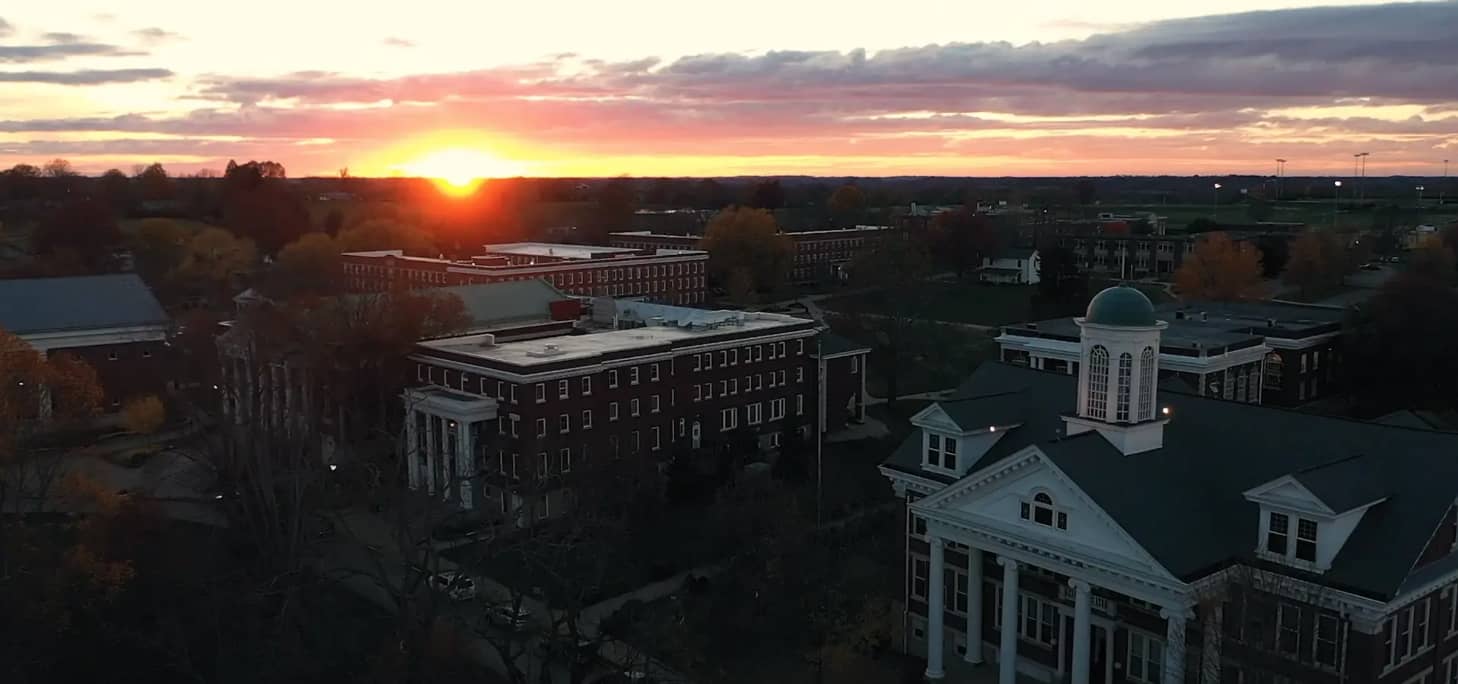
0,0 -> 1458,176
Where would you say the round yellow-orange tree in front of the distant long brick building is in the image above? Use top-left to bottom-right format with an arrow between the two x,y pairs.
703,207 -> 795,293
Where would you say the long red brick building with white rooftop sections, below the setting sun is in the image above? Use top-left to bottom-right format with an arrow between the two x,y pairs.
344,242 -> 709,305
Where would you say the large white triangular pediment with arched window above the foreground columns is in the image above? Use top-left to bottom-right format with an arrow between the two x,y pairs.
913,446 -> 1178,582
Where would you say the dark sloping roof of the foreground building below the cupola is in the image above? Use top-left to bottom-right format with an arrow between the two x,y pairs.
885,363 -> 1458,599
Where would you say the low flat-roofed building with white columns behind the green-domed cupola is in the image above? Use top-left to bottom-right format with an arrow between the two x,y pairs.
997,302 -> 1346,405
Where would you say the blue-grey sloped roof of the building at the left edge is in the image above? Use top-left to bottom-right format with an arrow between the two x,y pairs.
0,273 -> 169,335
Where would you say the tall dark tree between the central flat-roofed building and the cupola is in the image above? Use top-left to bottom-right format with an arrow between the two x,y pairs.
850,238 -> 930,405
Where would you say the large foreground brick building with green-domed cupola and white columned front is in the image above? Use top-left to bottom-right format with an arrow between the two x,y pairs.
881,287 -> 1458,684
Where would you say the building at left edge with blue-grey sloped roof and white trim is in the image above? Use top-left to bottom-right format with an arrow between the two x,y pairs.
0,273 -> 174,414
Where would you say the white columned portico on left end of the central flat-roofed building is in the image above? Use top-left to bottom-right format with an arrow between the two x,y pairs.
402,386 -> 497,509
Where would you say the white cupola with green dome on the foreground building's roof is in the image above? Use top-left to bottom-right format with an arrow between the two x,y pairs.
1064,284 -> 1169,455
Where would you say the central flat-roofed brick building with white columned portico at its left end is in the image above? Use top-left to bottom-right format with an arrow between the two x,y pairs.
404,299 -> 868,525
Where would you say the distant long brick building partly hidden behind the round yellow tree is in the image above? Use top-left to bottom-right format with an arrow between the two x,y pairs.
608,226 -> 891,284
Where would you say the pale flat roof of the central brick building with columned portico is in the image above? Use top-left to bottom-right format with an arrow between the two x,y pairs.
420,306 -> 815,366
